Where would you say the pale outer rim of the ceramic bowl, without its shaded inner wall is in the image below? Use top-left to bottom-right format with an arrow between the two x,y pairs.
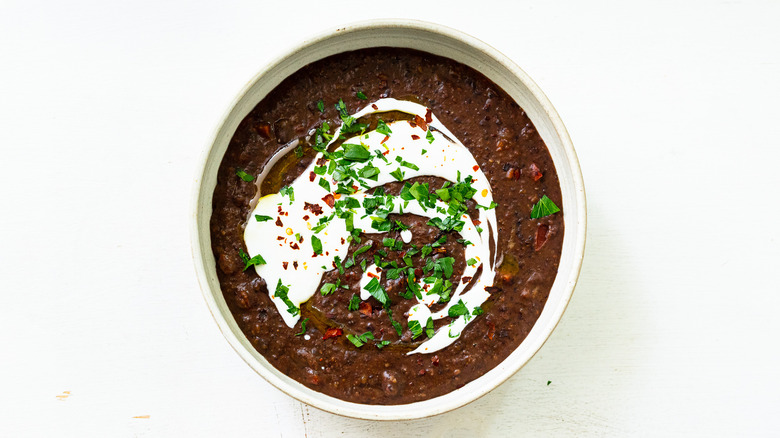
189,19 -> 587,420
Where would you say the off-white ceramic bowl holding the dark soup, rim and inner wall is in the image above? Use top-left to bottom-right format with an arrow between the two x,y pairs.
191,20 -> 586,420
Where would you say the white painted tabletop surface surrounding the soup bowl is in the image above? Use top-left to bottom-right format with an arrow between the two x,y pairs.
0,0 -> 780,437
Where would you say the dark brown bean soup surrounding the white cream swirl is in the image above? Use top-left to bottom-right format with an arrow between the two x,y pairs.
211,48 -> 564,405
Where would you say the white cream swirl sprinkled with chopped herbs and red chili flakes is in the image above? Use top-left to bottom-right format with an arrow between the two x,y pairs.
244,98 -> 498,354
